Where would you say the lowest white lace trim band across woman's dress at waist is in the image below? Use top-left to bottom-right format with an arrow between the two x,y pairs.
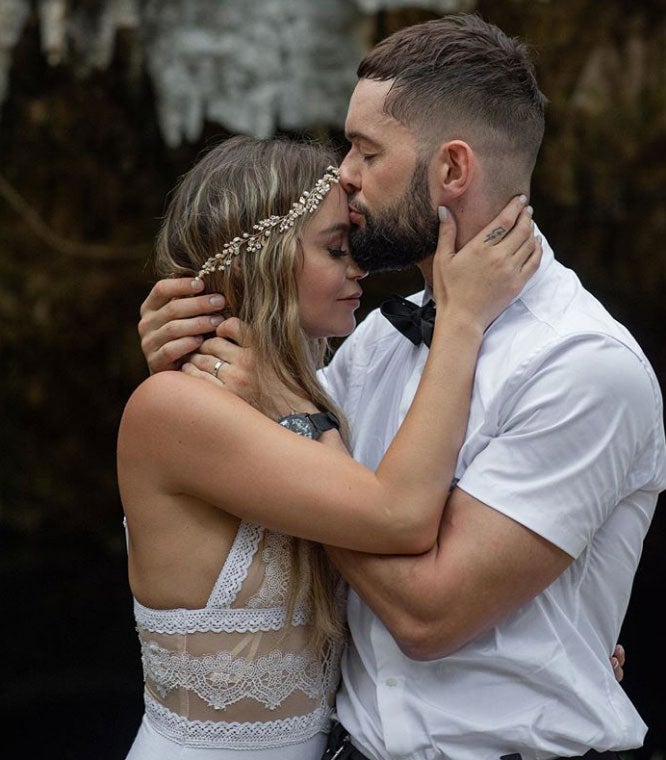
144,694 -> 333,749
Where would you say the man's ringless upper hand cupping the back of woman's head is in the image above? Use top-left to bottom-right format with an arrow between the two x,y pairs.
138,277 -> 224,374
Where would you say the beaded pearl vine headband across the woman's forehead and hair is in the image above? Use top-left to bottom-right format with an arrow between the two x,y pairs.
192,166 -> 340,279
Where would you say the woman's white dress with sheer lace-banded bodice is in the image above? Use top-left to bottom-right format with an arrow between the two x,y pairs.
127,522 -> 341,760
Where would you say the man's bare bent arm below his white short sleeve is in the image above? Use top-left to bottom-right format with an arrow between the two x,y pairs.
328,488 -> 572,660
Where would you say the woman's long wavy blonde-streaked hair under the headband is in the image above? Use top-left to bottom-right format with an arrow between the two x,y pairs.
154,136 -> 348,645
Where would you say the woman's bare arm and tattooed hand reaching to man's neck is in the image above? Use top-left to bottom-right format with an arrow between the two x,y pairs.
118,197 -> 540,553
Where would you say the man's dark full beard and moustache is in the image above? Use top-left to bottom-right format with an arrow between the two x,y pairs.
349,161 -> 439,272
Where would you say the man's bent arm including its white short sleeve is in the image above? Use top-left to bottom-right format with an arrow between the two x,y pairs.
330,335 -> 659,659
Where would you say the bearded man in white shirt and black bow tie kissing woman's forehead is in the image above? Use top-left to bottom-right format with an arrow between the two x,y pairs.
134,15 -> 666,760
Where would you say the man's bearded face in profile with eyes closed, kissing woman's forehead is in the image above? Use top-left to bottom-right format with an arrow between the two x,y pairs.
340,79 -> 438,272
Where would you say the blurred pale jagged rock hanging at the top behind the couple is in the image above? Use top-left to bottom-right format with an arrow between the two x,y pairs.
0,0 -> 476,147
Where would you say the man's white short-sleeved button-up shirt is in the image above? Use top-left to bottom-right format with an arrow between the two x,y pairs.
322,235 -> 666,760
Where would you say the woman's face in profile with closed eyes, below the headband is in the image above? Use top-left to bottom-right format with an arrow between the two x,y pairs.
297,184 -> 366,338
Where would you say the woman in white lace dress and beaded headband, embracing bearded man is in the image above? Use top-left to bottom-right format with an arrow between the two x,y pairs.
118,137 -> 541,760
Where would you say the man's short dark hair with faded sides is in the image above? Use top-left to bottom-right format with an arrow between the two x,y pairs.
357,14 -> 547,190
